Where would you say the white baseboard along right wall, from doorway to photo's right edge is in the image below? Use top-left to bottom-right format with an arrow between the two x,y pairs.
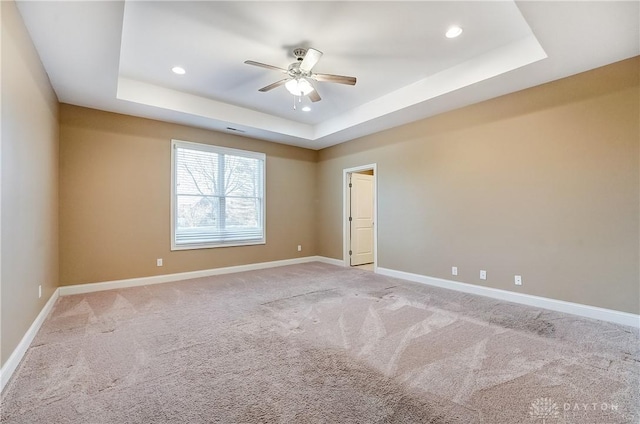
376,268 -> 640,327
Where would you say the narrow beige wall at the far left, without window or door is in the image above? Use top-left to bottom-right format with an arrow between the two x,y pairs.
0,1 -> 58,364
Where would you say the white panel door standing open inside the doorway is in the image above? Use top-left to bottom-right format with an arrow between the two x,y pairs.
349,173 -> 373,265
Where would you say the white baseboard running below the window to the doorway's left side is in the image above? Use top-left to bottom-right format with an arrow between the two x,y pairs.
58,256 -> 341,296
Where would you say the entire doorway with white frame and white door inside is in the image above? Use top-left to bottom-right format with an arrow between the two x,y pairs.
343,164 -> 378,272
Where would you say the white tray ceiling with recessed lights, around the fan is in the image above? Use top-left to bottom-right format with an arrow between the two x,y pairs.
18,1 -> 640,149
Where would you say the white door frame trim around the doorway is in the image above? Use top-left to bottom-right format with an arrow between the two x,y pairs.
342,163 -> 378,272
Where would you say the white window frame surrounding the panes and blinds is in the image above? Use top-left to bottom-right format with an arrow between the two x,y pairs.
171,139 -> 267,251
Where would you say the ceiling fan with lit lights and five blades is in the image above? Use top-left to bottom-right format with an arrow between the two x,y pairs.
244,48 -> 356,102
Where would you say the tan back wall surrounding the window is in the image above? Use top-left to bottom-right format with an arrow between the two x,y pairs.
60,104 -> 317,285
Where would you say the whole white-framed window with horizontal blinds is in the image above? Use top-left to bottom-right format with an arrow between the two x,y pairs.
171,140 -> 265,250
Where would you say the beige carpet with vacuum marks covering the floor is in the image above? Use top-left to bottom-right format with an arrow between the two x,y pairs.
0,263 -> 640,424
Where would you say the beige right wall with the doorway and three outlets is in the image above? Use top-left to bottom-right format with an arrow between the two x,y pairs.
318,58 -> 640,313
